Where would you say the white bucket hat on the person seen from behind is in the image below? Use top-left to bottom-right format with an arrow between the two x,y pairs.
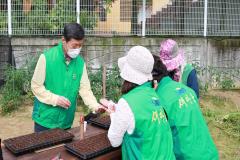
118,46 -> 154,85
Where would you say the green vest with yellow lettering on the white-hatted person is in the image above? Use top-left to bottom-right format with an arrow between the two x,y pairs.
122,83 -> 175,160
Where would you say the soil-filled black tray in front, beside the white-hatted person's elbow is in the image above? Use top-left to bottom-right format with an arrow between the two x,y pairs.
65,133 -> 117,160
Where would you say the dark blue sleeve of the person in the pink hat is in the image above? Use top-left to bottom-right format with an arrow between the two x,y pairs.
187,69 -> 199,98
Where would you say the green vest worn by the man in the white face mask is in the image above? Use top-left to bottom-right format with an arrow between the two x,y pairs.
32,43 -> 84,129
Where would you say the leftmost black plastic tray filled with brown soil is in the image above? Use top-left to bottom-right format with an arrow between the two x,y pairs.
3,129 -> 74,155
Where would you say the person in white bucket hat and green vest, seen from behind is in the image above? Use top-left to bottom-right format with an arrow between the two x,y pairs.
100,46 -> 175,160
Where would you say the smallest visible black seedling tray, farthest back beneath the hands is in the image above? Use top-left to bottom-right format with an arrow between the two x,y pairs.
88,115 -> 111,129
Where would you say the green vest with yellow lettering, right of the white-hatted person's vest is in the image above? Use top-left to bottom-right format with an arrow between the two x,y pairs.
157,77 -> 219,160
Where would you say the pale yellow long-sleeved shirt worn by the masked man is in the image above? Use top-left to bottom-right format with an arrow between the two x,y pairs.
31,54 -> 99,110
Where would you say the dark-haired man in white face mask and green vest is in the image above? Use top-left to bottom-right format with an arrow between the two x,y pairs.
31,23 -> 100,132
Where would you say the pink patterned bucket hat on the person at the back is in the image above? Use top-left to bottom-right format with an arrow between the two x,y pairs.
160,39 -> 184,71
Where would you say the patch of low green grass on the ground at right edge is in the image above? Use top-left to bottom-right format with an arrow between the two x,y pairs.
200,93 -> 240,140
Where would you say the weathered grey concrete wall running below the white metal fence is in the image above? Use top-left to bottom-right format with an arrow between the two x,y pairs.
0,37 -> 240,87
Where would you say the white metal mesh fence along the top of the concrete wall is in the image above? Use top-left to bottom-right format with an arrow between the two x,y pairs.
0,0 -> 240,36
